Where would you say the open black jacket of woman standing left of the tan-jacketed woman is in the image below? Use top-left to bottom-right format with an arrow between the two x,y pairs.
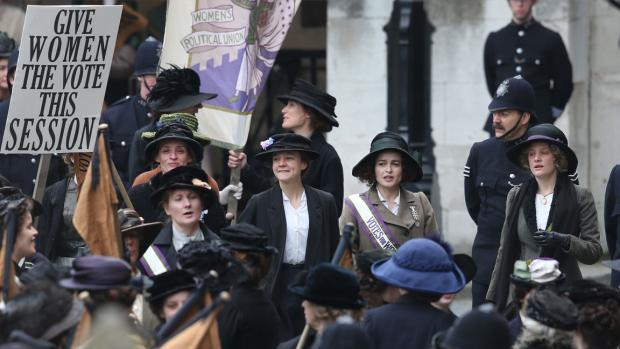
239,185 -> 340,297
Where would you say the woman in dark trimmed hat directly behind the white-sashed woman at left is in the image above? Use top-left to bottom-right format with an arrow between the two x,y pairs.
129,113 -> 226,232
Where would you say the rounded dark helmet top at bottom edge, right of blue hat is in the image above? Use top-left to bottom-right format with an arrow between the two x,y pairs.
442,304 -> 512,349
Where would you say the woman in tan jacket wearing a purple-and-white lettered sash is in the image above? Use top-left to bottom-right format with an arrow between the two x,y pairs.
340,132 -> 438,252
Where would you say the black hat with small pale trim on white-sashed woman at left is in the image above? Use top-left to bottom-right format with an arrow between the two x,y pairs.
151,166 -> 215,209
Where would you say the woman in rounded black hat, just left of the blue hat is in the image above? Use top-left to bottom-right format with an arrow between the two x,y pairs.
278,263 -> 366,349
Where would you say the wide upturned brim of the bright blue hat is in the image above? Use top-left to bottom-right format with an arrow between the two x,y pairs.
371,254 -> 466,294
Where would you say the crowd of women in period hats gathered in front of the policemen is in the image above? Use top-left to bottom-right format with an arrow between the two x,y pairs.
0,63 -> 620,349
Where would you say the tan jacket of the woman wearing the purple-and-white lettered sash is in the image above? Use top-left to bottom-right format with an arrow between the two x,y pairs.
340,186 -> 439,252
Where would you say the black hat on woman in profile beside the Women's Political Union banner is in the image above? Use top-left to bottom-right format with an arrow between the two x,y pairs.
278,79 -> 338,127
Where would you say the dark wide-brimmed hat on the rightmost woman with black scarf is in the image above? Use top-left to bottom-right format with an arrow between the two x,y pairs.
506,124 -> 579,175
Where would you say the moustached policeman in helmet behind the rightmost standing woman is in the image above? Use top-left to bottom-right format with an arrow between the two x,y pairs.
463,76 -> 536,307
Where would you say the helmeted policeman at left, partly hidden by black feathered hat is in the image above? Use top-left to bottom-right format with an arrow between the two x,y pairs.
101,37 -> 161,187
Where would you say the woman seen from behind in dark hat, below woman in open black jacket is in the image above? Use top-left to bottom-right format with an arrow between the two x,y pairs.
217,223 -> 279,349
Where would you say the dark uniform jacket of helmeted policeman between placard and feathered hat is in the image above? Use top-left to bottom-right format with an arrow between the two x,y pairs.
101,96 -> 152,187
